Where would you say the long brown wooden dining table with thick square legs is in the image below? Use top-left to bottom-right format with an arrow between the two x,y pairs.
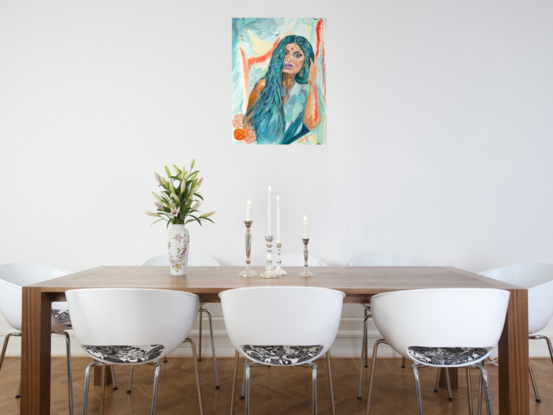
21,266 -> 530,415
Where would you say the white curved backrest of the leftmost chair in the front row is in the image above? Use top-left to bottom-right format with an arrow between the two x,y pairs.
65,288 -> 199,358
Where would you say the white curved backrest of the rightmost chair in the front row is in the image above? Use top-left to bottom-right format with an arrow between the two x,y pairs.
371,288 -> 509,364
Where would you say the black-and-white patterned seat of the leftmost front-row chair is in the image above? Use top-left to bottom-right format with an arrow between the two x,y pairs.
83,344 -> 164,364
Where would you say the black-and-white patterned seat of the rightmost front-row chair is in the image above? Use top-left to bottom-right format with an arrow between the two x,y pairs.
407,346 -> 488,366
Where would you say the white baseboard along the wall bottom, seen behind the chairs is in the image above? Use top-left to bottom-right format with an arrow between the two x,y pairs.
0,315 -> 553,357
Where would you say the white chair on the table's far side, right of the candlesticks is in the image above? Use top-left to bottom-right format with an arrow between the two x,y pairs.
349,254 -> 426,400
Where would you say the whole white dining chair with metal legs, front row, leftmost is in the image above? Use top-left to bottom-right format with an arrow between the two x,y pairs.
65,288 -> 203,415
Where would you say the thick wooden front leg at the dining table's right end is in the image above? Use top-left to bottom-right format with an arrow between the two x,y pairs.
498,289 -> 530,415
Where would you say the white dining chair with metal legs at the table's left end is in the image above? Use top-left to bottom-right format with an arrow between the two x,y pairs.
0,264 -> 73,415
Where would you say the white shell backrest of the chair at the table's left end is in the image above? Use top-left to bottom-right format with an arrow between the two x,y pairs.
0,264 -> 71,331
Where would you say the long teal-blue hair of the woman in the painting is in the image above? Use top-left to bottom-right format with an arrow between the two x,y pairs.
246,35 -> 315,144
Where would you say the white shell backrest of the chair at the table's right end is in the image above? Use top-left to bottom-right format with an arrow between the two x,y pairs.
480,264 -> 553,334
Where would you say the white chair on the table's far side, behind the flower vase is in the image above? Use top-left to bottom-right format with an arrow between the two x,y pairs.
141,252 -> 219,393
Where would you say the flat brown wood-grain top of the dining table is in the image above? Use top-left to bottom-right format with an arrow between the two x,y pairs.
29,266 -> 518,303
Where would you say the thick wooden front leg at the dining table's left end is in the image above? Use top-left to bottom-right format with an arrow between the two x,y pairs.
21,287 -> 52,415
